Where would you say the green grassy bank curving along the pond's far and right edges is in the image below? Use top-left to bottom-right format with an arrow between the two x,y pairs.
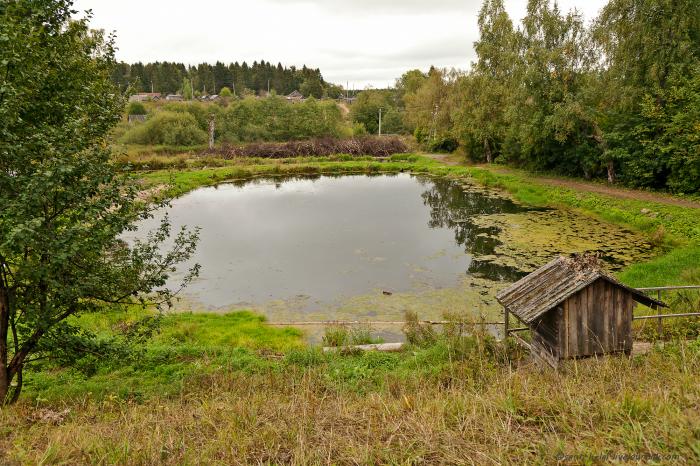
139,154 -> 700,287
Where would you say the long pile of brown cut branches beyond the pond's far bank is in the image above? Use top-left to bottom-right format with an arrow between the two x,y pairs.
206,137 -> 408,159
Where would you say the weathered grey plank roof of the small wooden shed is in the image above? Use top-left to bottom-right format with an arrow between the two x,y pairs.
496,256 -> 666,324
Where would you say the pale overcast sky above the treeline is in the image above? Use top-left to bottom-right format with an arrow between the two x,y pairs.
75,0 -> 607,89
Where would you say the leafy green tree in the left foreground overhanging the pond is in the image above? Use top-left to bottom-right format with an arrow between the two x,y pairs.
0,0 -> 197,404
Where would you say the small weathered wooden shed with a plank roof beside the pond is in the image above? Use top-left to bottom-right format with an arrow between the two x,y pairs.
496,256 -> 666,367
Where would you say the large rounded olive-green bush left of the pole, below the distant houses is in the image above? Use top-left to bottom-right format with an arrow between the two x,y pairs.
122,112 -> 207,146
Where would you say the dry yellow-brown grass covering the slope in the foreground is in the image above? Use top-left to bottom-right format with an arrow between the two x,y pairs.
0,344 -> 700,465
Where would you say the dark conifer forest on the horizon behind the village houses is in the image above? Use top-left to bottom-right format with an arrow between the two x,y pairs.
112,60 -> 342,98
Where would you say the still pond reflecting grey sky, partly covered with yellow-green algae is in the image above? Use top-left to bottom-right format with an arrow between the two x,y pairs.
139,174 -> 651,340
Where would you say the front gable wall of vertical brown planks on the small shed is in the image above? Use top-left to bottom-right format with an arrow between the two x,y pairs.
550,279 -> 635,359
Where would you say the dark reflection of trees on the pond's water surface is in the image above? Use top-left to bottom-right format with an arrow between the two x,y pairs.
419,178 -> 528,281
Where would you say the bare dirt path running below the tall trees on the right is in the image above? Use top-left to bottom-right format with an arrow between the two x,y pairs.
425,154 -> 700,209
